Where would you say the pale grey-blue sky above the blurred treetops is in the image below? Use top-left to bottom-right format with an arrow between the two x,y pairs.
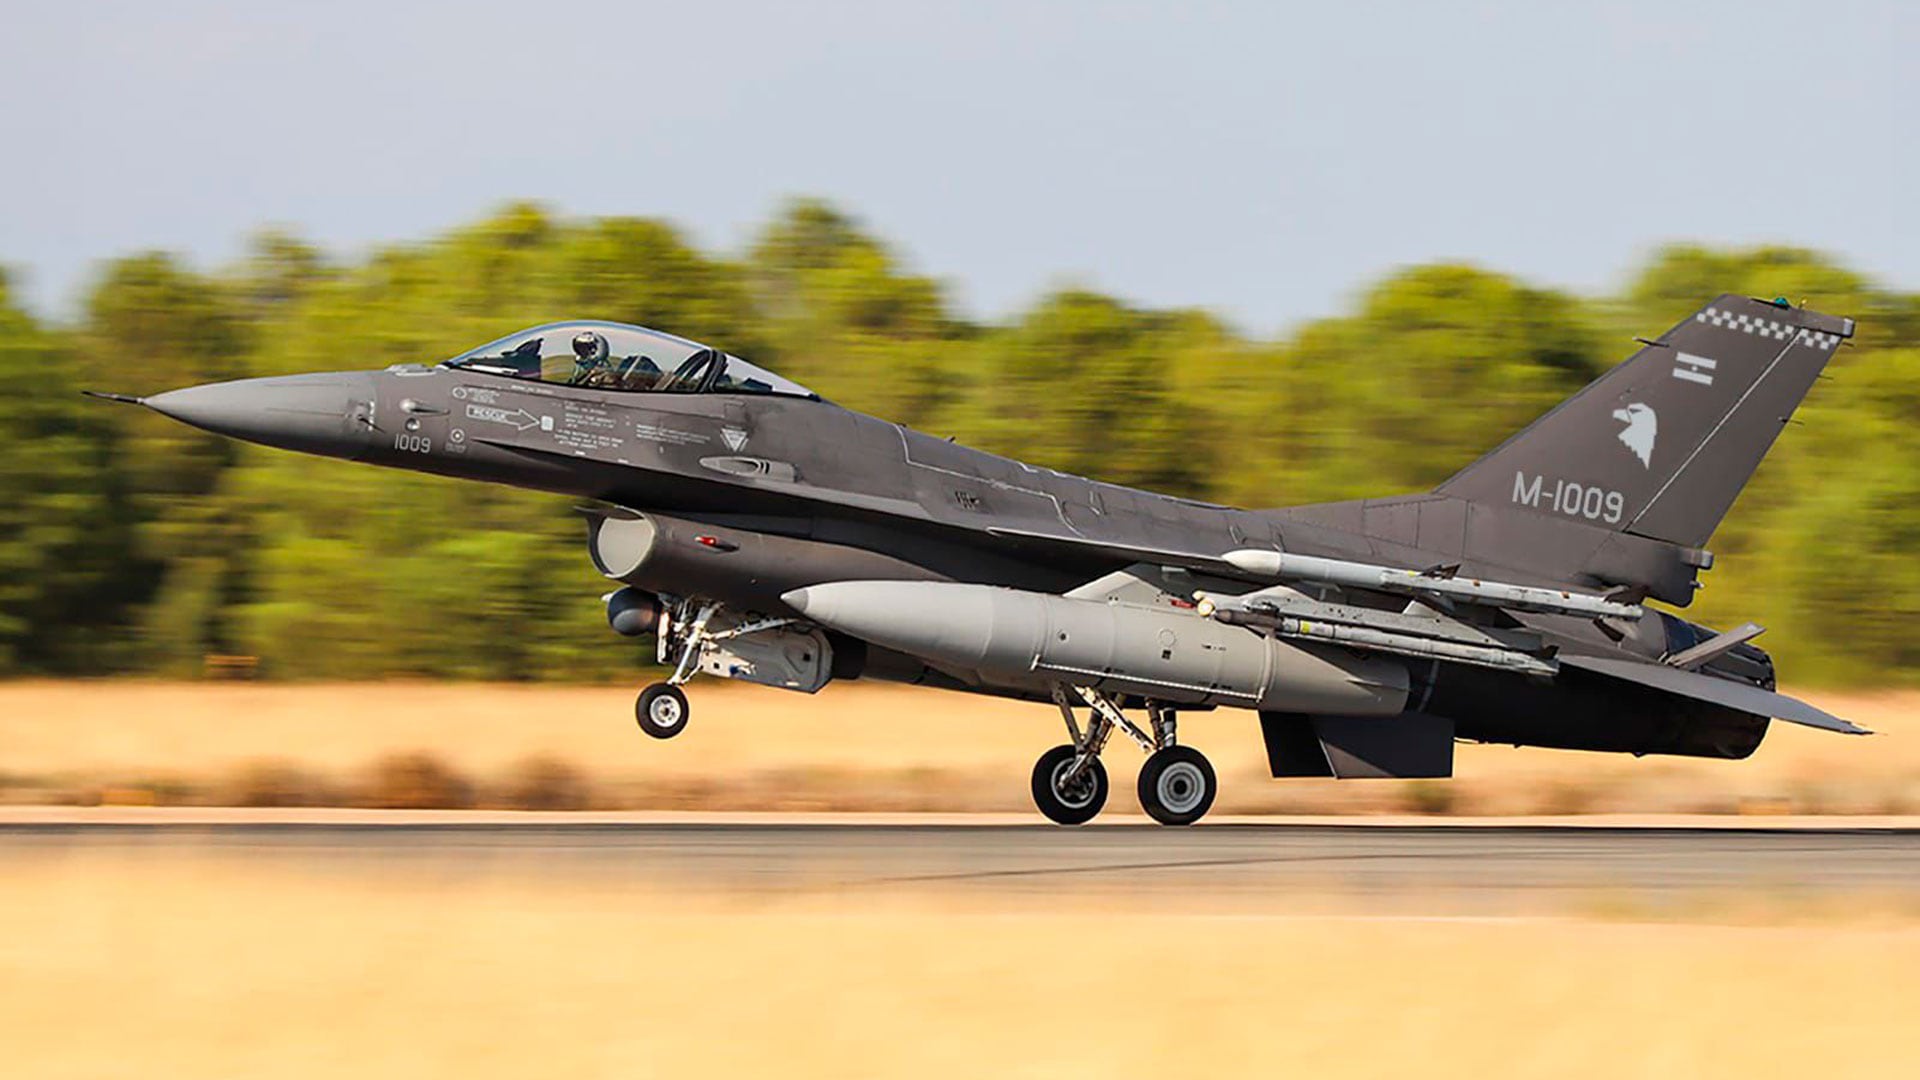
0,0 -> 1920,332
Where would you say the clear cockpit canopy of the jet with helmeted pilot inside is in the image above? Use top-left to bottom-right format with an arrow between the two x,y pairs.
445,321 -> 818,398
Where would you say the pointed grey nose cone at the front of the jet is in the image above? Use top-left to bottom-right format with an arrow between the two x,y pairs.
146,371 -> 374,457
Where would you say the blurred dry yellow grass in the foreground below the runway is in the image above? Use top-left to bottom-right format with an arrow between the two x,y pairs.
0,849 -> 1920,1080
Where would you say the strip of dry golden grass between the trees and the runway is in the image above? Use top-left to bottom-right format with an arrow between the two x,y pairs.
0,682 -> 1920,813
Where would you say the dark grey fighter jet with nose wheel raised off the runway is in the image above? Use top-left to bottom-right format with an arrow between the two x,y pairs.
86,294 -> 1866,824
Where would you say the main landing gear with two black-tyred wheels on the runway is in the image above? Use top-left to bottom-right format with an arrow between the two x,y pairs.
1033,686 -> 1219,824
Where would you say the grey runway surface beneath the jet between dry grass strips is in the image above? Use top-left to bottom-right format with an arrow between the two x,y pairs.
0,819 -> 1920,913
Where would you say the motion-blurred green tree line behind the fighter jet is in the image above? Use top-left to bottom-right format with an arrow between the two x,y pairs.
0,200 -> 1920,682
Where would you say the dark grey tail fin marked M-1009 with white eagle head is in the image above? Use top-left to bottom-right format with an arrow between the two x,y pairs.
1436,294 -> 1853,548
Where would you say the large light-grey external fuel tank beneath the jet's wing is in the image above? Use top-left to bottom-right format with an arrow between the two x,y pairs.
781,580 -> 1407,717
